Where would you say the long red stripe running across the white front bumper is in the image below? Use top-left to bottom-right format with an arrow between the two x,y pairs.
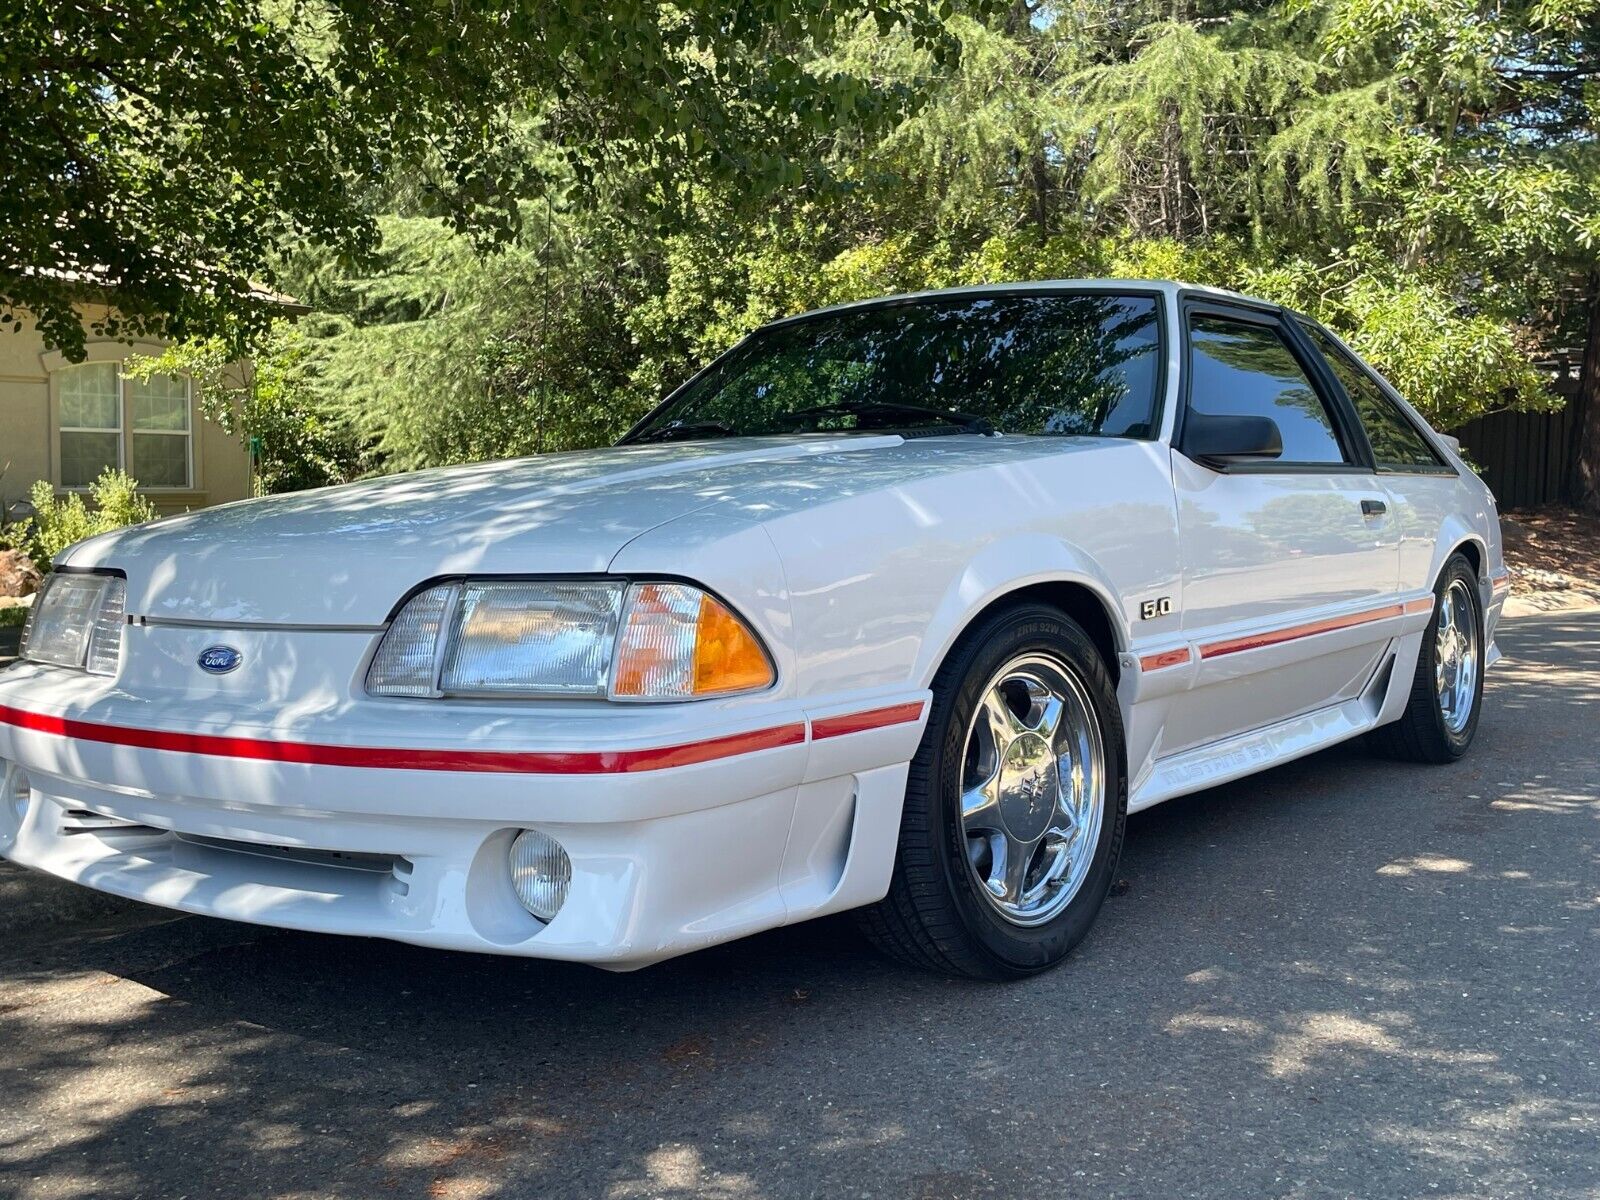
0,706 -> 805,774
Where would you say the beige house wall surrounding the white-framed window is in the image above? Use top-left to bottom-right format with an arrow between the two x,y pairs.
0,306 -> 250,512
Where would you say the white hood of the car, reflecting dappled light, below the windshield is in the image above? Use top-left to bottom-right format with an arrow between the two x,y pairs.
61,435 -> 1113,626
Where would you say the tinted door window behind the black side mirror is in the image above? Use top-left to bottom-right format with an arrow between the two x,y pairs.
1189,314 -> 1347,464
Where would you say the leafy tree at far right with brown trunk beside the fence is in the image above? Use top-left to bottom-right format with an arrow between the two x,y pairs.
1278,0 -> 1600,512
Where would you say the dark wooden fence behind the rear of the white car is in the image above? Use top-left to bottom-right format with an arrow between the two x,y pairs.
1453,357 -> 1579,509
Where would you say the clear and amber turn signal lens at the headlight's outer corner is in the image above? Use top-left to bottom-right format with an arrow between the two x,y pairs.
611,584 -> 774,699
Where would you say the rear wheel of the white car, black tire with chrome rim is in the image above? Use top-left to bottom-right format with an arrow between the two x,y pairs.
1373,554 -> 1486,763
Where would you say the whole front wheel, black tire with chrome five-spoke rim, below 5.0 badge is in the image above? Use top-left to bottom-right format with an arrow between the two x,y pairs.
861,603 -> 1128,979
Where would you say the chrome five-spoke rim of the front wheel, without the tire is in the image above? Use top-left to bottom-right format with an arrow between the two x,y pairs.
962,654 -> 1106,926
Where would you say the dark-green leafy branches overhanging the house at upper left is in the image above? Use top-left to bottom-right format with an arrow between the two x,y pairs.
0,0 -> 949,357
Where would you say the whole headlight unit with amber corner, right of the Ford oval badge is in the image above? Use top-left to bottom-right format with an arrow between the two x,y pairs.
366,579 -> 774,701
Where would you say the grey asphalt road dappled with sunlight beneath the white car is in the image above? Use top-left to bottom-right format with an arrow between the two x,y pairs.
0,613 -> 1600,1200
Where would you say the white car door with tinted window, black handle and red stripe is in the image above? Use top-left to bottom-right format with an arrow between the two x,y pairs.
1162,302 -> 1400,754
